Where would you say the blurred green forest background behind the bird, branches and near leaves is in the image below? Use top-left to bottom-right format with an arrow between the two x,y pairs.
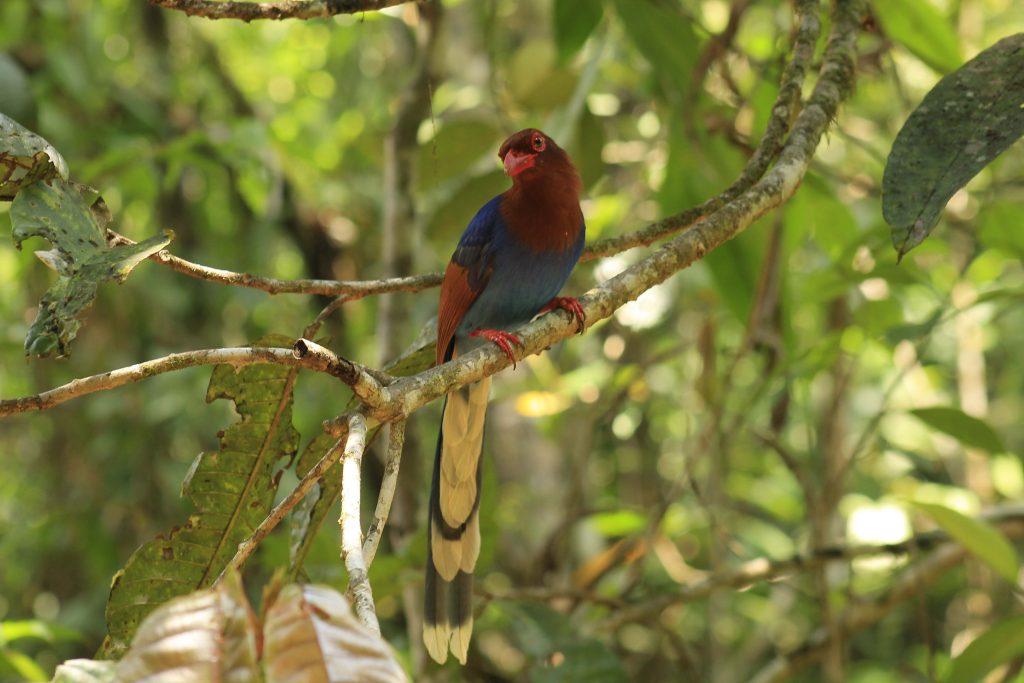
0,0 -> 1024,683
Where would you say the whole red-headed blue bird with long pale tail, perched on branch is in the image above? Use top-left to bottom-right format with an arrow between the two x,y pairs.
423,128 -> 586,665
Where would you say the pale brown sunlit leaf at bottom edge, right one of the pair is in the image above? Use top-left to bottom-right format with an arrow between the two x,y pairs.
263,584 -> 409,683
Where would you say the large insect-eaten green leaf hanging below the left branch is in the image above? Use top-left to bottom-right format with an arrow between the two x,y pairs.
103,337 -> 298,655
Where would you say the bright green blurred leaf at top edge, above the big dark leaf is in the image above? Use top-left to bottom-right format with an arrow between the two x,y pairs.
871,0 -> 964,73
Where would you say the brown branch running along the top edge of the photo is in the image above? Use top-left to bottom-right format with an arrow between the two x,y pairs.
150,0 -> 410,22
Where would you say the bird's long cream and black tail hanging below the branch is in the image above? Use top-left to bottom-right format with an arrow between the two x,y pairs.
423,377 -> 490,664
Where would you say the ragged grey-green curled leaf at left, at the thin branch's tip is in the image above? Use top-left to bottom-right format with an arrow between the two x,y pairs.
10,179 -> 174,356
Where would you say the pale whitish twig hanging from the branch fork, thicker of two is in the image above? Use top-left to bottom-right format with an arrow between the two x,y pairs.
338,413 -> 381,636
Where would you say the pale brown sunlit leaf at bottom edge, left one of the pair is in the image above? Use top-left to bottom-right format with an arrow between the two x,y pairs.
117,571 -> 259,683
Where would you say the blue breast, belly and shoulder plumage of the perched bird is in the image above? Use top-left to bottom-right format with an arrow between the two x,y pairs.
454,196 -> 586,339
